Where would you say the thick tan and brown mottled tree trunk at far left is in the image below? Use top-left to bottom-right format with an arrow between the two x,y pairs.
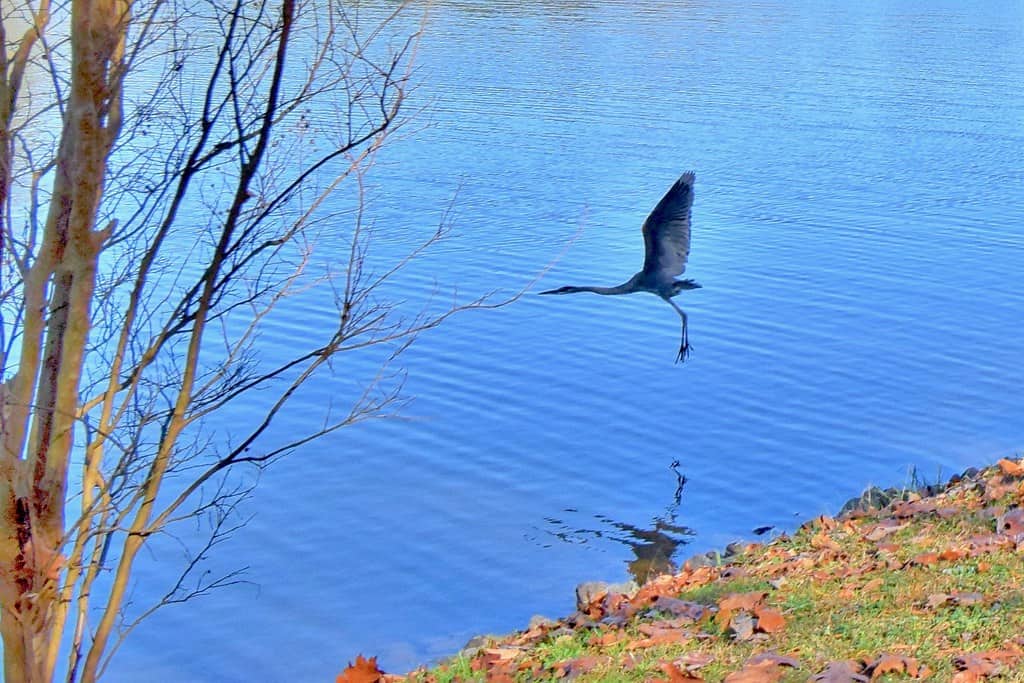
0,0 -> 122,682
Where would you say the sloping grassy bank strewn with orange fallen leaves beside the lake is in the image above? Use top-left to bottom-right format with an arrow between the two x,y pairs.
338,460 -> 1024,683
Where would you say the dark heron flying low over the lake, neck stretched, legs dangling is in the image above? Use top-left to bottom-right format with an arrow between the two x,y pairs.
541,171 -> 700,362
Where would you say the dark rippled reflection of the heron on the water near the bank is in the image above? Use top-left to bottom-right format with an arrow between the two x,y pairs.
545,460 -> 695,585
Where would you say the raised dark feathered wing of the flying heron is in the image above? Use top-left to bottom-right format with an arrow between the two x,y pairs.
643,171 -> 696,278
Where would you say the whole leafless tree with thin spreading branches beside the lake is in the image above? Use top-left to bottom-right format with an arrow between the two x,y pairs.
0,0 -> 497,681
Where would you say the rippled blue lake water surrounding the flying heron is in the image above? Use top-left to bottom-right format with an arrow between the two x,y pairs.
110,0 -> 1024,681
